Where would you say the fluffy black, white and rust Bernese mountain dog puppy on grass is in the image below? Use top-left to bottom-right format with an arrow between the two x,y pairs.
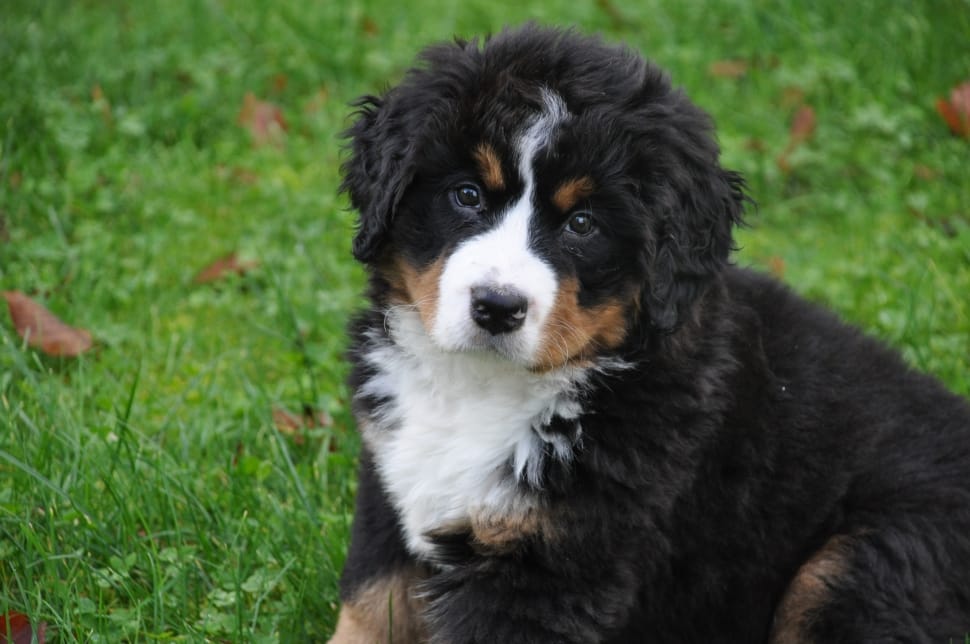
332,25 -> 970,644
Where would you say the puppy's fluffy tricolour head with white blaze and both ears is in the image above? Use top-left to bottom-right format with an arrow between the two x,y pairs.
343,25 -> 744,370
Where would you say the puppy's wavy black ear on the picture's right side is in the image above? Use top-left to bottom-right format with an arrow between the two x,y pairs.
644,91 -> 748,333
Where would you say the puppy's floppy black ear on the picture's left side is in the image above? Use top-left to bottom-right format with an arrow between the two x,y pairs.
340,96 -> 414,263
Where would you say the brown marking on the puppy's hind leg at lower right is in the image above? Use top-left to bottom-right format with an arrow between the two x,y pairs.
770,535 -> 849,644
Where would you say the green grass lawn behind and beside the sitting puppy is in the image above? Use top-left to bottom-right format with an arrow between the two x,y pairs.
0,0 -> 970,642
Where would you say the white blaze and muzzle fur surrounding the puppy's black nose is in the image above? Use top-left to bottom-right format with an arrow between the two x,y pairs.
430,89 -> 568,362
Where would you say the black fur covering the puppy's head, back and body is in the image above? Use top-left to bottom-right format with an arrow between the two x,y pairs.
334,26 -> 970,644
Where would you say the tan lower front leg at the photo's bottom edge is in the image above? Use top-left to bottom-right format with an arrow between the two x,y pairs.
330,571 -> 427,644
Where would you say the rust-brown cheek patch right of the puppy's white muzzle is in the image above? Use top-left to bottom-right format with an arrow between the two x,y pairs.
532,279 -> 633,372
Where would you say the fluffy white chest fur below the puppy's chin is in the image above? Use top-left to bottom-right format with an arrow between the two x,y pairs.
361,310 -> 585,556
